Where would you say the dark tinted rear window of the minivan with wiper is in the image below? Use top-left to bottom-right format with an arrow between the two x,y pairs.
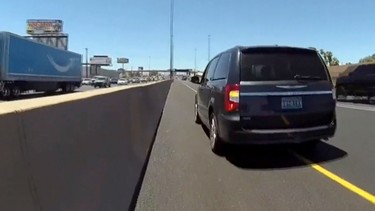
241,48 -> 329,81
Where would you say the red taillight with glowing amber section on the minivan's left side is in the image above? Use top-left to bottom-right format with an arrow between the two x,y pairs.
224,84 -> 240,112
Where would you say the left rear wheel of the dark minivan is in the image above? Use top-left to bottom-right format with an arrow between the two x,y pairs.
210,113 -> 225,156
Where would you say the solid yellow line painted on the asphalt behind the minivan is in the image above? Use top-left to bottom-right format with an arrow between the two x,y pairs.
292,152 -> 375,205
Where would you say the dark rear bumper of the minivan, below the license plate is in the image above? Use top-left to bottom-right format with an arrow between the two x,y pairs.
218,114 -> 336,144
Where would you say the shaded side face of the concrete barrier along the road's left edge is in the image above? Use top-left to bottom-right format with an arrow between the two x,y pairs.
0,81 -> 171,211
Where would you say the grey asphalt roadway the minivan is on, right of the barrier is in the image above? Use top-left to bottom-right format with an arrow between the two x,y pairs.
135,80 -> 375,211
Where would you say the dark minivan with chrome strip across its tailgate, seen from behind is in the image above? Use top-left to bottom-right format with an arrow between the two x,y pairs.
191,46 -> 336,153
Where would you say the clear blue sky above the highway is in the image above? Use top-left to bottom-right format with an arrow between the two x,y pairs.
0,0 -> 375,69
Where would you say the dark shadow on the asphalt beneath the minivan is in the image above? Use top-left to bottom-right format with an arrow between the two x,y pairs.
203,127 -> 347,169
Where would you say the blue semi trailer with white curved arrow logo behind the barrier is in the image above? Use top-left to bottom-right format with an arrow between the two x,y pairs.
0,32 -> 82,98
